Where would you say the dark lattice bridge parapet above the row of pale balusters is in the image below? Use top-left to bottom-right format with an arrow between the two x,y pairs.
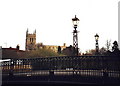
1,56 -> 120,72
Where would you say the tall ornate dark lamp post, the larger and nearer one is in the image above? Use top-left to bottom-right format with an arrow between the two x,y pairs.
72,15 -> 79,55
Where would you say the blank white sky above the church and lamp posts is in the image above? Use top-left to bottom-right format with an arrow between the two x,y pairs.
0,0 -> 119,52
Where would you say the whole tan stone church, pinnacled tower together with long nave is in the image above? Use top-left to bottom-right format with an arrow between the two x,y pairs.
25,29 -> 67,52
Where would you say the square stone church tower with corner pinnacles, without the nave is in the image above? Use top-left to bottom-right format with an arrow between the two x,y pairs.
25,29 -> 36,51
